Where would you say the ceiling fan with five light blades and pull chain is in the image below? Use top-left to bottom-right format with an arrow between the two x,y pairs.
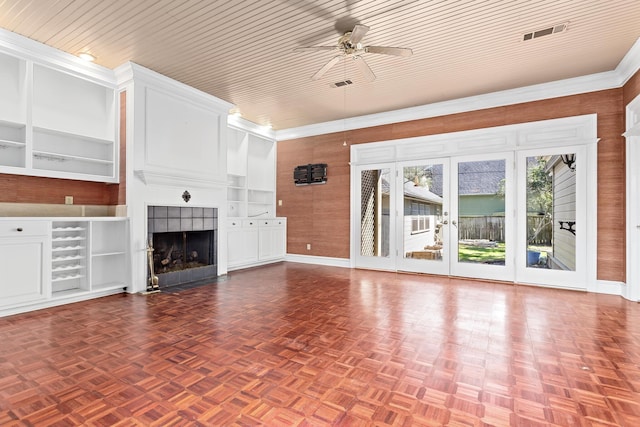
293,24 -> 413,81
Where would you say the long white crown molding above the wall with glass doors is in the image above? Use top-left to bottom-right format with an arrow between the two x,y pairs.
276,39 -> 640,141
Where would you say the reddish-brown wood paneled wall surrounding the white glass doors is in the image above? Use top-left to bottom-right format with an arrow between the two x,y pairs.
276,88 -> 637,281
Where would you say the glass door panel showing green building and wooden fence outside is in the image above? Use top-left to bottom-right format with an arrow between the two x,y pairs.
450,153 -> 514,280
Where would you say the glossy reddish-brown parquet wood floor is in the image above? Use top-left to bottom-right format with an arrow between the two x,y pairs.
0,263 -> 640,426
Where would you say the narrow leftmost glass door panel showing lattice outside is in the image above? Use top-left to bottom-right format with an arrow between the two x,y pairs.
356,165 -> 395,269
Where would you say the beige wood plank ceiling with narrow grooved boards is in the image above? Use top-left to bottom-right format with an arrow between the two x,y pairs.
0,0 -> 640,129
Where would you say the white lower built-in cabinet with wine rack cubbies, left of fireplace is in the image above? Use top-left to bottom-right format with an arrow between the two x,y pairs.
0,221 -> 131,316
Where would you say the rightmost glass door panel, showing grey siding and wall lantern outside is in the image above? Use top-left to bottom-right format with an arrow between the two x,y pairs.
517,147 -> 586,288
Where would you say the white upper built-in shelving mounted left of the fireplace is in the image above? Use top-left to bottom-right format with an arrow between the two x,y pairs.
0,31 -> 119,182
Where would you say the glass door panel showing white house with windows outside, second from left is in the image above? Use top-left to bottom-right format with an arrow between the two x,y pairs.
396,159 -> 450,274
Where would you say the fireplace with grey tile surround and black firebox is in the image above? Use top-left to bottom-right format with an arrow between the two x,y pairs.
147,206 -> 218,288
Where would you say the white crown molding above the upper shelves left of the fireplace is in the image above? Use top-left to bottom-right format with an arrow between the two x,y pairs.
0,28 -> 116,89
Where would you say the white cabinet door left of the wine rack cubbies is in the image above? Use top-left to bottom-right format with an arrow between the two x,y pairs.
0,224 -> 48,306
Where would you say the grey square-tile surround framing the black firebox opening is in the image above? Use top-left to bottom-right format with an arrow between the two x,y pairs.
147,206 -> 218,288
